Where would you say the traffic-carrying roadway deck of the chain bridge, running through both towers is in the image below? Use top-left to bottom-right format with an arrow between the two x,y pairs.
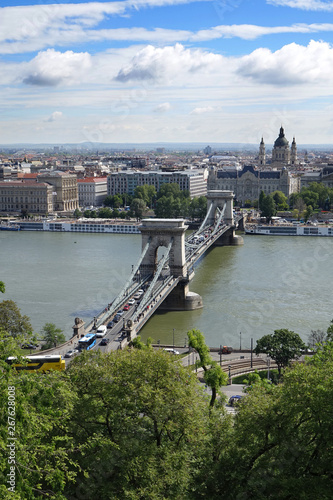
87,222 -> 237,350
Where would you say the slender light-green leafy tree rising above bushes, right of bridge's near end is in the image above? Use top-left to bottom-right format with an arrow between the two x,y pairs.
187,329 -> 228,407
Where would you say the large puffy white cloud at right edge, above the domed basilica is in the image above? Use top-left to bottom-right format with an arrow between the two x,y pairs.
238,41 -> 333,86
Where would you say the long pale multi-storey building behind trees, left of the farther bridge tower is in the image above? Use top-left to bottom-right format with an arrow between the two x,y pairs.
108,171 -> 207,198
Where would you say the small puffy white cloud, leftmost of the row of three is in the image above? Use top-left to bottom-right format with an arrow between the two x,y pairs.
23,49 -> 91,87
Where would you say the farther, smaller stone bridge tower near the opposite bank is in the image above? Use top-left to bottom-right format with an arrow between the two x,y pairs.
207,190 -> 244,246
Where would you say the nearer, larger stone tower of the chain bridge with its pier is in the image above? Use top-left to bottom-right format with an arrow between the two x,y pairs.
140,219 -> 202,311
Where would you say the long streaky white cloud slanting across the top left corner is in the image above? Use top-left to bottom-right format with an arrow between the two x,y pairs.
0,0 -> 211,53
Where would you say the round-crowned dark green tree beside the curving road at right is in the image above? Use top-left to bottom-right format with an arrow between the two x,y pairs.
254,329 -> 306,377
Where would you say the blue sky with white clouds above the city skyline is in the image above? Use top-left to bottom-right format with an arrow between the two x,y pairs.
0,0 -> 333,147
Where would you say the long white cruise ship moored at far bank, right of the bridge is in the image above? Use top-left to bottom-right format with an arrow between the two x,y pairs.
245,224 -> 333,236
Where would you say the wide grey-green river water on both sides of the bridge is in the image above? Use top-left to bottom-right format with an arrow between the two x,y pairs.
0,231 -> 333,348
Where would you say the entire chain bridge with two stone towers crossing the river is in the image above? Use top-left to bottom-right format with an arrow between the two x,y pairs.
77,191 -> 243,341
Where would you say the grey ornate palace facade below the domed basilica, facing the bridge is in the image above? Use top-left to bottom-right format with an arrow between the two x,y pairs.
208,165 -> 299,204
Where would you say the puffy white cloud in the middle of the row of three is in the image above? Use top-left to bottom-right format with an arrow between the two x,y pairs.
116,43 -> 223,82
